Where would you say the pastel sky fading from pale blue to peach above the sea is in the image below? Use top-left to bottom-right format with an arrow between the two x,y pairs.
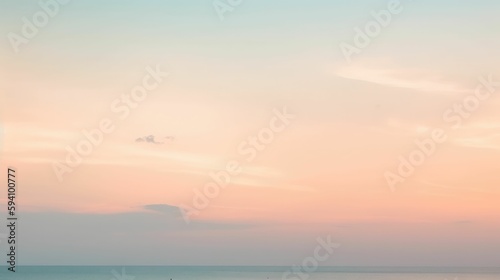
0,0 -> 500,266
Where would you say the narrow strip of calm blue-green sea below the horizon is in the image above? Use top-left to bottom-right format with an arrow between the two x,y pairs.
0,266 -> 500,280
